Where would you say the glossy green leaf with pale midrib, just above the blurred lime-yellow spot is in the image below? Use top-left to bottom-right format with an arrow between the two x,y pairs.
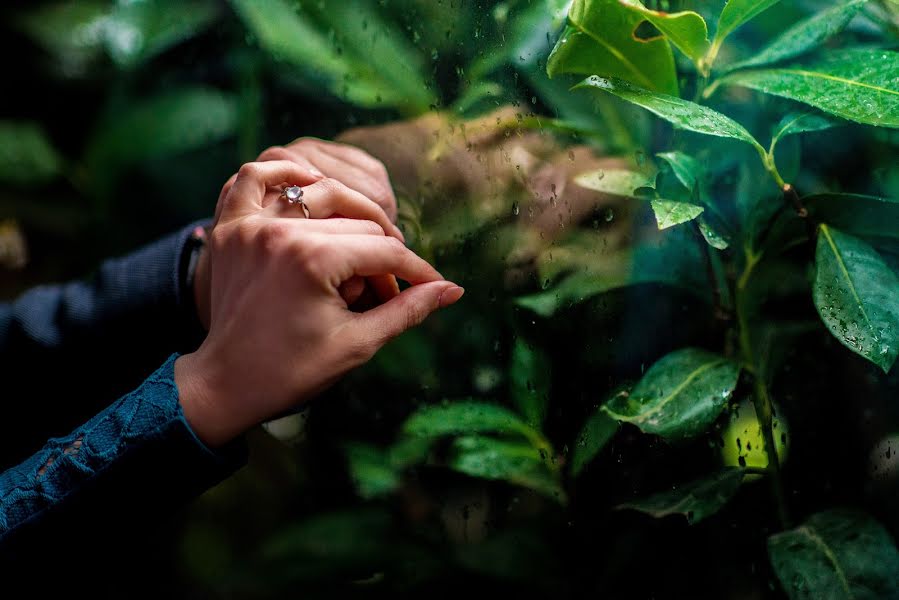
603,348 -> 740,440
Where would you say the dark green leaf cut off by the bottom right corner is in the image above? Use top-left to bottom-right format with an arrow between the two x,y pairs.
768,510 -> 899,600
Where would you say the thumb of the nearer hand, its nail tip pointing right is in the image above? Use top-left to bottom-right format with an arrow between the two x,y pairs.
359,281 -> 465,348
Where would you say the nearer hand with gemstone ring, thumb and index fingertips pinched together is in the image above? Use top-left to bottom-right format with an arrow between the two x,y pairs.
175,161 -> 463,446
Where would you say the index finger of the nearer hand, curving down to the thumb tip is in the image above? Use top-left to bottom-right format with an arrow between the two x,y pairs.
328,235 -> 443,285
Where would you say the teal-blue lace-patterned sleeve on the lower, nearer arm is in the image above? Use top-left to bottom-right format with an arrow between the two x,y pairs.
0,354 -> 246,550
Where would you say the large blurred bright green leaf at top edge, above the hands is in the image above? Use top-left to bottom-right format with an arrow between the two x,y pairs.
231,0 -> 433,113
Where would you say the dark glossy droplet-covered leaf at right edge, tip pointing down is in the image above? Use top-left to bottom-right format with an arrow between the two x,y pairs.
812,224 -> 899,373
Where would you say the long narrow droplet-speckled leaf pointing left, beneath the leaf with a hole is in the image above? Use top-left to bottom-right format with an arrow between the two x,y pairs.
574,76 -> 764,153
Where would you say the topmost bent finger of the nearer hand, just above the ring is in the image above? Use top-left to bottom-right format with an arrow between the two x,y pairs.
221,160 -> 326,219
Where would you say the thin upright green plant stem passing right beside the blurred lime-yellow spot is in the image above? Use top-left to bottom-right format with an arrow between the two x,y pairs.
735,247 -> 790,529
